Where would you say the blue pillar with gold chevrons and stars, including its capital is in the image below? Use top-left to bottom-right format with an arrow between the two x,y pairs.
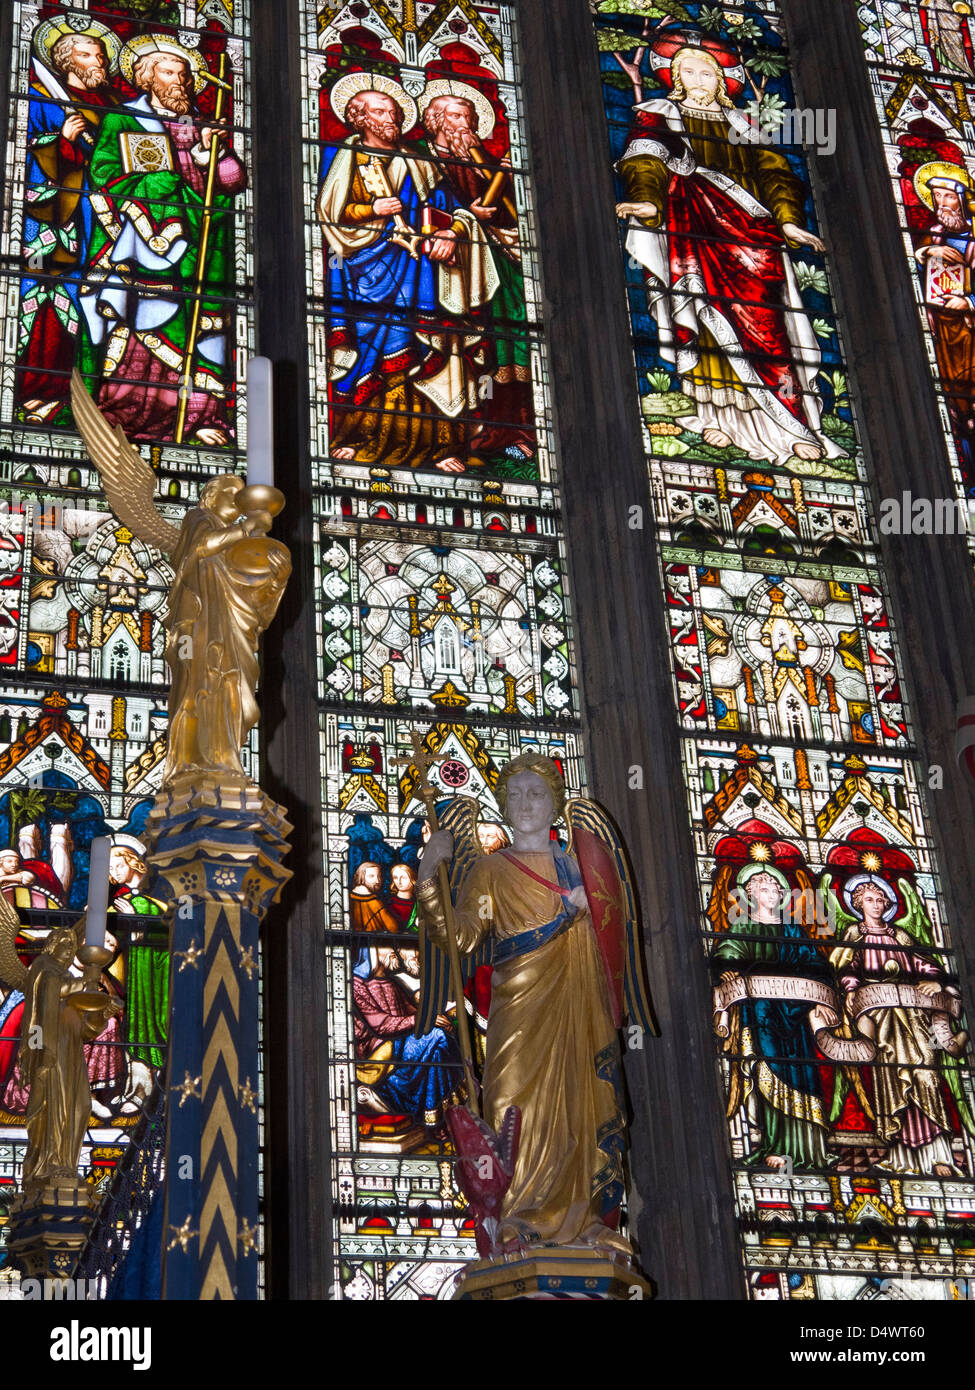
147,776 -> 291,1300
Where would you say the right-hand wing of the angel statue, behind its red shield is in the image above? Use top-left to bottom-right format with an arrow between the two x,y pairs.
565,796 -> 659,1037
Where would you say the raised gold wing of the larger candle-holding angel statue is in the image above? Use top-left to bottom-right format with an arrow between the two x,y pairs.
71,367 -> 179,555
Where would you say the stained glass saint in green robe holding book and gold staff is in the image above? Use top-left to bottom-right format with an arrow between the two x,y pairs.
79,38 -> 248,445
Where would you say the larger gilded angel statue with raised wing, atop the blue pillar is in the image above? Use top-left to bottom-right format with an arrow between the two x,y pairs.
71,371 -> 291,787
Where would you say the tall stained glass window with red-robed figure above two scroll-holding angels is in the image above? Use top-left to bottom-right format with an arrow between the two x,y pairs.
593,0 -> 975,1300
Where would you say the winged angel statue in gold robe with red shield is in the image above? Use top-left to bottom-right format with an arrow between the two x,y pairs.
417,753 -> 652,1255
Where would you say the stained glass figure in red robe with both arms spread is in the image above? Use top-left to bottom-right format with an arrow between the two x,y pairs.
616,39 -> 843,473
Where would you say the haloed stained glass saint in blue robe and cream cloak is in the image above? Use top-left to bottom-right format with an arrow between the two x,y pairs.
317,72 -> 499,473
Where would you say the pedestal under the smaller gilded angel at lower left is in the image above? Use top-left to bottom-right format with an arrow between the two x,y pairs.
7,1177 -> 95,1279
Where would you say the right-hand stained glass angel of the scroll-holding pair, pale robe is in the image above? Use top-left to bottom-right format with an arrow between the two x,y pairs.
822,873 -> 975,1177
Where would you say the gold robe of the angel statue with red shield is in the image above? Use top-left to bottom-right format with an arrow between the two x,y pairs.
417,851 -> 630,1254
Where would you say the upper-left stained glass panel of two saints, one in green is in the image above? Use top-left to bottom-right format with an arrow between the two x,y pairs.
0,4 -> 250,446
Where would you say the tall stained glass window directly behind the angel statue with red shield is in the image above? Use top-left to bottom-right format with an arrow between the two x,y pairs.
302,0 -> 584,1298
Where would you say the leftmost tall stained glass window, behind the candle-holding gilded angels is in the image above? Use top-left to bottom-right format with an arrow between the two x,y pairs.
0,0 -> 256,1278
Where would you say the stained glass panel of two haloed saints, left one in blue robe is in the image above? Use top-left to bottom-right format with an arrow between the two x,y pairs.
296,4 -> 552,505
